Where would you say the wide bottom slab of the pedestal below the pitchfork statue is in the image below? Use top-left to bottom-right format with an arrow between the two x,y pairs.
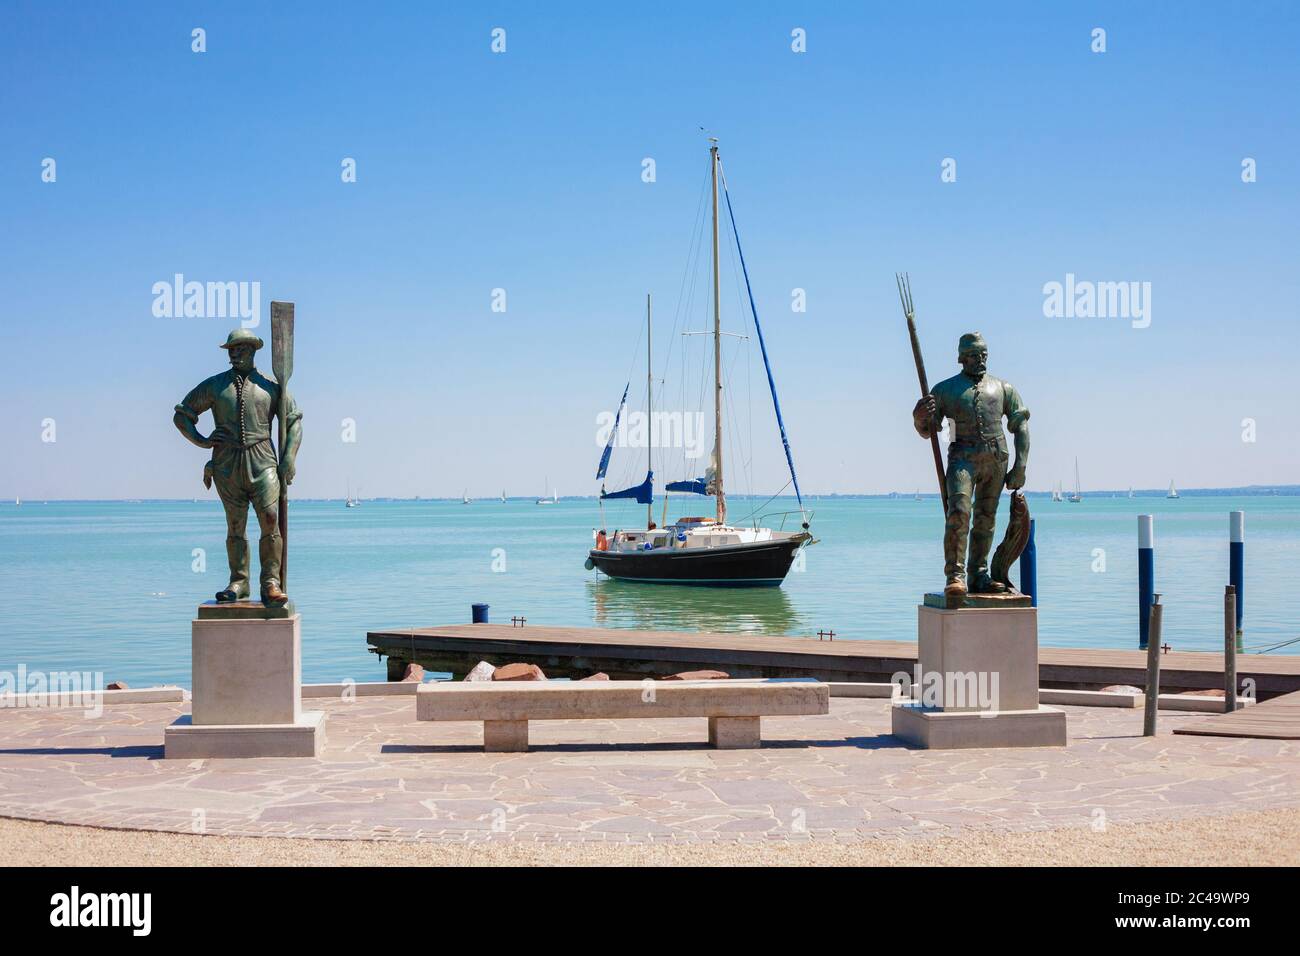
891,701 -> 1066,750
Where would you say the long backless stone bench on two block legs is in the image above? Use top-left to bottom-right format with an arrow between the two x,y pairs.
415,678 -> 831,753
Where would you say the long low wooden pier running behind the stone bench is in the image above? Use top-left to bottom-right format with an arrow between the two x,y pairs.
367,624 -> 1300,700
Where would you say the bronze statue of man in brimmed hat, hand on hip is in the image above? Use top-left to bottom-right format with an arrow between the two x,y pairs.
173,329 -> 303,607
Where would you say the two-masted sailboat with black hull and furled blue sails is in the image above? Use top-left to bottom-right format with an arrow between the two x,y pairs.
586,138 -> 813,587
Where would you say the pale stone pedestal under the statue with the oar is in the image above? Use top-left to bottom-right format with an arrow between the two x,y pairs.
164,614 -> 325,760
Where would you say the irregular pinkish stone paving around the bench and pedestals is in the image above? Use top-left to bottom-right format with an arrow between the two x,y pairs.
0,697 -> 1300,843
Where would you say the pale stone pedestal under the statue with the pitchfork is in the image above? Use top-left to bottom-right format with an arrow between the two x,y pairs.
892,605 -> 1066,749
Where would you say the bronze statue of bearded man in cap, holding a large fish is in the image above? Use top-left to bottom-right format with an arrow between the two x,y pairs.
913,332 -> 1030,598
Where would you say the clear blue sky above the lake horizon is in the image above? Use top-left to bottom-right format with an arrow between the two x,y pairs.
0,3 -> 1300,498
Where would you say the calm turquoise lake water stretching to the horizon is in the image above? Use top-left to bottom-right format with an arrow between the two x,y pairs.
0,497 -> 1300,685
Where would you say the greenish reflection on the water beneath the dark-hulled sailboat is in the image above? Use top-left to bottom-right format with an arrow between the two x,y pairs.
586,575 -> 807,636
